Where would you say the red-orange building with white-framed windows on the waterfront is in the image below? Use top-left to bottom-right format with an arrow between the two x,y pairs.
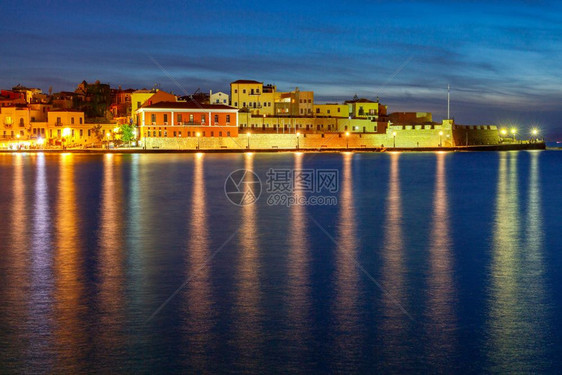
137,101 -> 238,138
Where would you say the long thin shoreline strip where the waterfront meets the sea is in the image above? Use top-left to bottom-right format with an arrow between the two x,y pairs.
0,143 -> 544,154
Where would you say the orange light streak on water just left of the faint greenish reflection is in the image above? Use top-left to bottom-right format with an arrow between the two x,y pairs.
96,154 -> 126,364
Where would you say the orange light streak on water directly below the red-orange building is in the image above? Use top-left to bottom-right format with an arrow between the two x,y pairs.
185,154 -> 216,373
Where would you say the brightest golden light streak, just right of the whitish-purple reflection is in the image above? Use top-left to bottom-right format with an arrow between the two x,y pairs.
53,154 -> 87,371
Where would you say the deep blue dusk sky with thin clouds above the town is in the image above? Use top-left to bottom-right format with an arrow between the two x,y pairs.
0,1 -> 562,140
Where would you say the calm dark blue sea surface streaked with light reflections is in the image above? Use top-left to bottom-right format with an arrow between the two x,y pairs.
0,151 -> 562,373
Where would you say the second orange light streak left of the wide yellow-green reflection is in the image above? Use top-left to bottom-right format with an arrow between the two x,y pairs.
381,153 -> 409,370
